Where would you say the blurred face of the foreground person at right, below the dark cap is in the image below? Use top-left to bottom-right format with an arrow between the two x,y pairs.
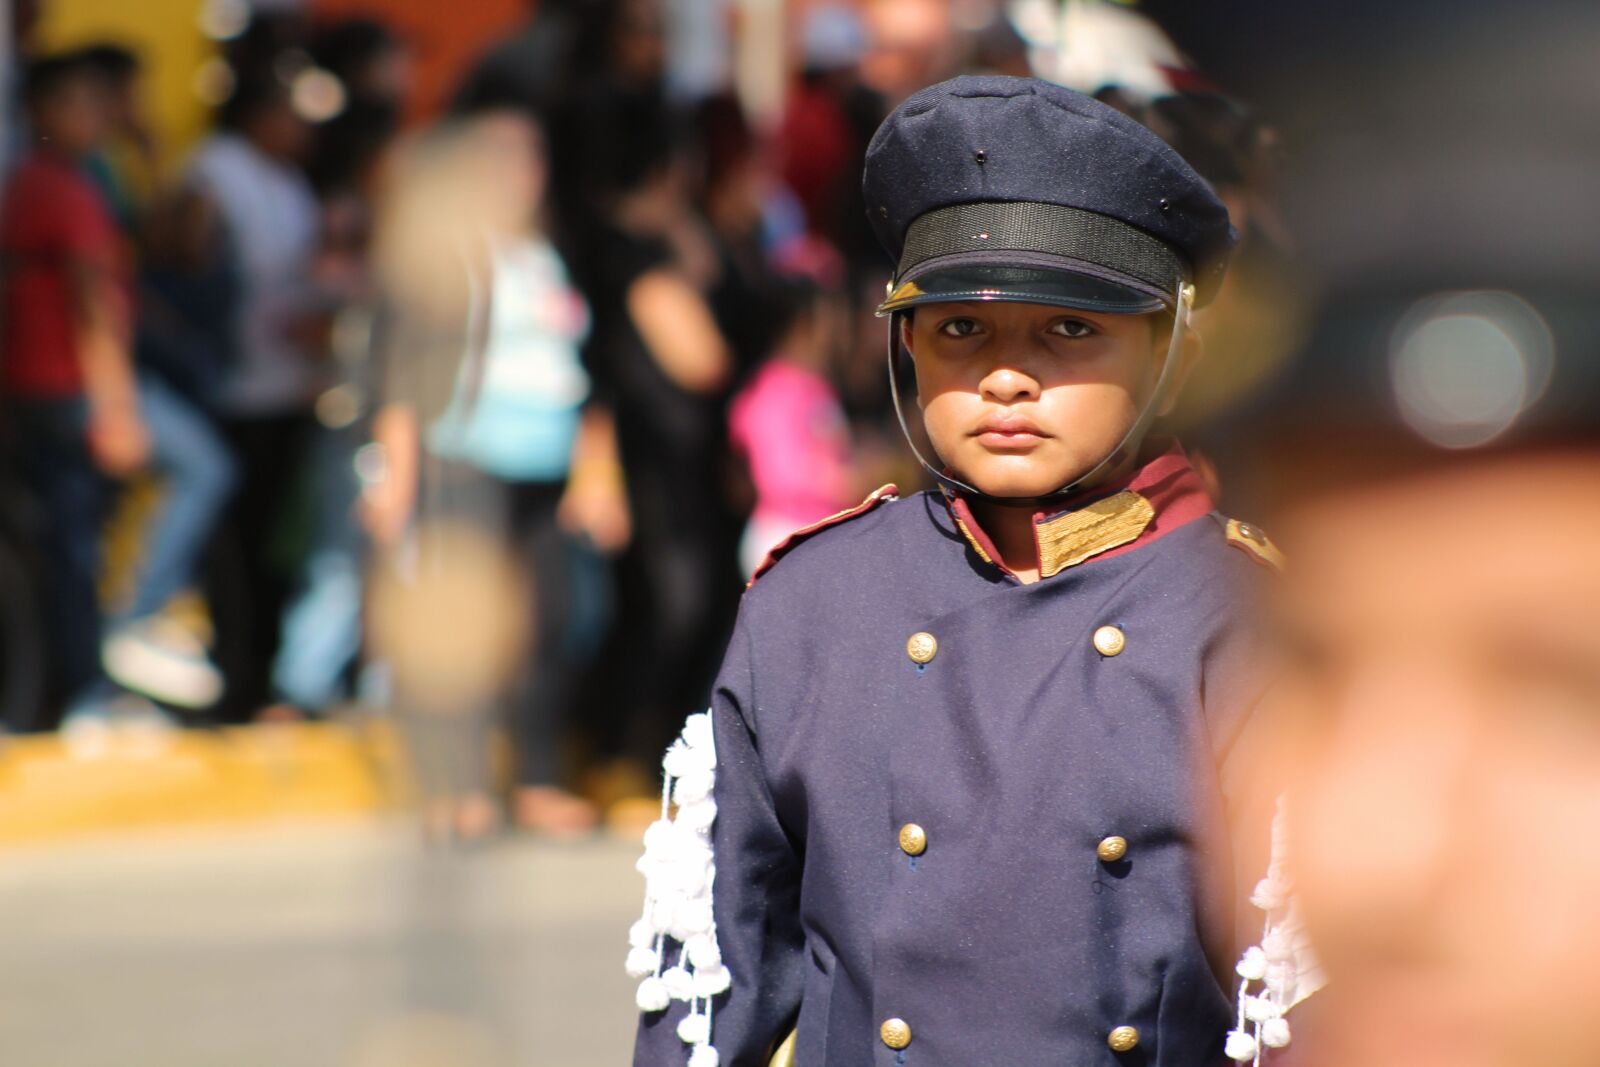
1278,445 -> 1600,1067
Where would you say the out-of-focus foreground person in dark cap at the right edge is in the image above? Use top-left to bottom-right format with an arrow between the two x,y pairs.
1228,8 -> 1600,1067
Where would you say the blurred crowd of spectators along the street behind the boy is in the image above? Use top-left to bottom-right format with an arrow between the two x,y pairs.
0,0 -> 1275,837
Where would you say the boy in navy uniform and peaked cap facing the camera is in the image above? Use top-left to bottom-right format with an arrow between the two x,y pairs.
629,77 -> 1293,1067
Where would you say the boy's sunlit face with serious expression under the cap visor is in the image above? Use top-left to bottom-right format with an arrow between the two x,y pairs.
902,301 -> 1165,498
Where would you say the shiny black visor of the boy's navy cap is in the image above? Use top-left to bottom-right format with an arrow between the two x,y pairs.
877,253 -> 1176,317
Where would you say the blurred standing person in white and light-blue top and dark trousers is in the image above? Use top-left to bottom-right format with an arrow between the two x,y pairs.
366,107 -> 626,837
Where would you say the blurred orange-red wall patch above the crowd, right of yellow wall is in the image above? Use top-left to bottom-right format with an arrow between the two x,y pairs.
307,0 -> 538,122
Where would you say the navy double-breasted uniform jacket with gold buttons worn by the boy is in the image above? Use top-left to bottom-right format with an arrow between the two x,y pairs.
634,448 -> 1266,1067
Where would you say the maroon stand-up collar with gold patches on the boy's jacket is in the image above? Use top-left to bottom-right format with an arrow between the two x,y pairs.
944,442 -> 1214,576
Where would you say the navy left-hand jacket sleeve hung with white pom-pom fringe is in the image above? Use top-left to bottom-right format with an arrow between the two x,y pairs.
630,600 -> 805,1067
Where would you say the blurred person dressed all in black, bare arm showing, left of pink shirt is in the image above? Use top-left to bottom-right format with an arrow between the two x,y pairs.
579,94 -> 738,819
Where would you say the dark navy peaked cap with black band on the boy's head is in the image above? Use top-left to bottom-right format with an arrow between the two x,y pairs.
862,75 -> 1234,314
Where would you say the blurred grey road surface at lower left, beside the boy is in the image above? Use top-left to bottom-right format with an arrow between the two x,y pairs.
0,821 -> 643,1067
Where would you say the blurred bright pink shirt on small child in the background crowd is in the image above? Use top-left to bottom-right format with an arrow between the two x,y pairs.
728,357 -> 854,553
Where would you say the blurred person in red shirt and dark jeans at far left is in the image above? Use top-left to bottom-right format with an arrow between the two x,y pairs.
0,56 -> 150,729
